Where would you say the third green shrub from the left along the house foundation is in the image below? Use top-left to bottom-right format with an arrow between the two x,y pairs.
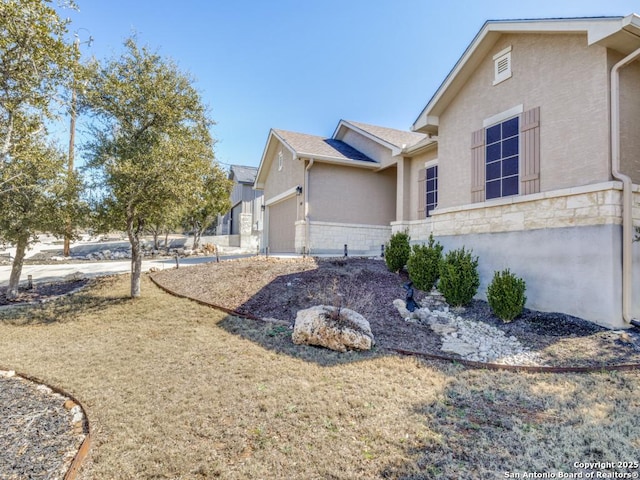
438,247 -> 480,307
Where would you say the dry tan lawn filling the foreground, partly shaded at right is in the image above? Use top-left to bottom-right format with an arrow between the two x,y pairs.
0,276 -> 640,480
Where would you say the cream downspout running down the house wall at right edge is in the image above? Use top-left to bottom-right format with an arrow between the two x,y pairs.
611,48 -> 640,327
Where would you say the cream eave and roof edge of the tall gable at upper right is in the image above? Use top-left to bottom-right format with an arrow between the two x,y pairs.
411,14 -> 640,132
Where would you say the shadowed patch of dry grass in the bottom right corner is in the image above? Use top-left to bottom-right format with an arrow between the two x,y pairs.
380,368 -> 640,480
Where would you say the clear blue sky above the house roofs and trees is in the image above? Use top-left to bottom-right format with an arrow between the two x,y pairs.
61,0 -> 640,171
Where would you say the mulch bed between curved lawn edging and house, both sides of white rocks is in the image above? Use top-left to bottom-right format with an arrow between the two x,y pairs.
154,257 -> 640,367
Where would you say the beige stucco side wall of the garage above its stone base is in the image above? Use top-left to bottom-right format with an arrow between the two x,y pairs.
308,162 -> 396,225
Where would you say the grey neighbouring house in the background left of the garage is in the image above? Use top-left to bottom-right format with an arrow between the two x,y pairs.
213,165 -> 262,251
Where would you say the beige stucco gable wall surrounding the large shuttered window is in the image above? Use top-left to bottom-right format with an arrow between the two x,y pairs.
438,34 -> 609,207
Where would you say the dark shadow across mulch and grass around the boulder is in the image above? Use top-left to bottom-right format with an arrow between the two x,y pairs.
212,258 -> 410,366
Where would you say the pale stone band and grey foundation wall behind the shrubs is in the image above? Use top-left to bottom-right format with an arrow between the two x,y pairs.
392,182 -> 640,328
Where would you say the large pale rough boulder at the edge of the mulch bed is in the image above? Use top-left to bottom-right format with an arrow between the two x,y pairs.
291,305 -> 375,352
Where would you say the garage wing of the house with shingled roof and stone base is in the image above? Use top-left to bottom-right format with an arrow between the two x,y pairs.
255,121 -> 427,254
